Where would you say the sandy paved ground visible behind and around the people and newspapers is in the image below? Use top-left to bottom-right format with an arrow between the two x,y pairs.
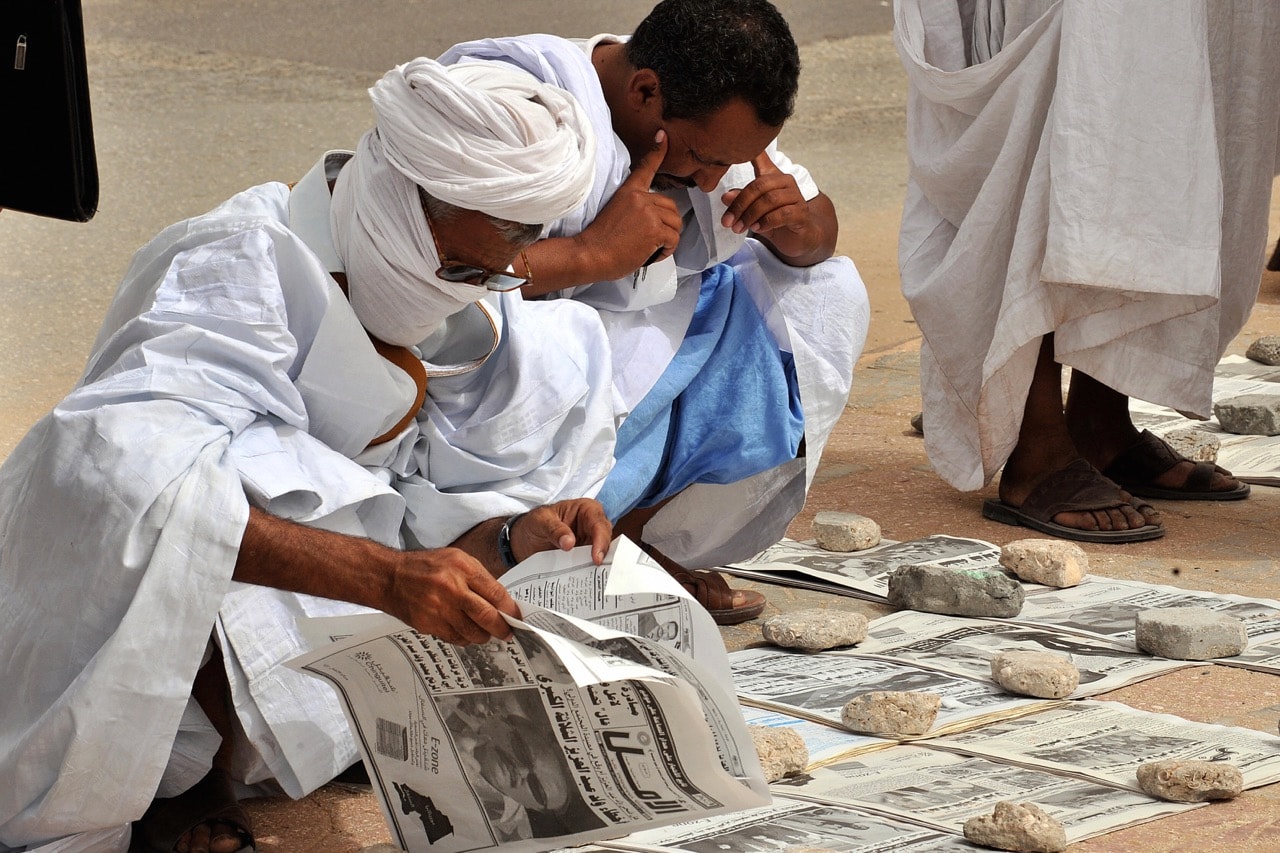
0,0 -> 1280,853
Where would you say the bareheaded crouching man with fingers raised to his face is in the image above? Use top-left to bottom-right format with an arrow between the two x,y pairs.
440,0 -> 869,624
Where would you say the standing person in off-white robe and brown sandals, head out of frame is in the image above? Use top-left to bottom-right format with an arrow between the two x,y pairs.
895,0 -> 1280,542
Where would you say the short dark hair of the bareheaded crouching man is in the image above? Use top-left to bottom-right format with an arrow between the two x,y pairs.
627,0 -> 800,127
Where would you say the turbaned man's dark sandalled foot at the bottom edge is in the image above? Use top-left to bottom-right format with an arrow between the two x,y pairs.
129,770 -> 257,853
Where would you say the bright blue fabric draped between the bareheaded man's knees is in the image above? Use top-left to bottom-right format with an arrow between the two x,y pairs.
598,264 -> 804,521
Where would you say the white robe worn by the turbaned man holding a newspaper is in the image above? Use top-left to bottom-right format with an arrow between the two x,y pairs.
0,155 -> 616,845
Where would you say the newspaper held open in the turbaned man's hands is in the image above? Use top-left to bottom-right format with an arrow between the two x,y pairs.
291,539 -> 769,853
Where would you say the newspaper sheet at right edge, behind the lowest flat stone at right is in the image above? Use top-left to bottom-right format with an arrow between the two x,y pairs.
928,699 -> 1280,790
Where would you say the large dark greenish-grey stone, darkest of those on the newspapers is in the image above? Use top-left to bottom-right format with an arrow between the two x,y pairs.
888,565 -> 1023,619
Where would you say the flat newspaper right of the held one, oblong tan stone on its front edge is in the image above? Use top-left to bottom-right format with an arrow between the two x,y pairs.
730,647 -> 1053,754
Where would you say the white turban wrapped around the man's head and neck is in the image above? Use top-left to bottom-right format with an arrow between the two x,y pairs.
330,59 -> 595,346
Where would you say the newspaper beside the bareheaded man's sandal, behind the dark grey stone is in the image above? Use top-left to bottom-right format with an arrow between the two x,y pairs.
722,534 -> 1007,602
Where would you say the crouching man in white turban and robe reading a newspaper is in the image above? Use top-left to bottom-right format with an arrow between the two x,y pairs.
0,59 -> 616,850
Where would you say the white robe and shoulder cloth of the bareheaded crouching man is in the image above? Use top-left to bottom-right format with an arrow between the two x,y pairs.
440,33 -> 870,567
